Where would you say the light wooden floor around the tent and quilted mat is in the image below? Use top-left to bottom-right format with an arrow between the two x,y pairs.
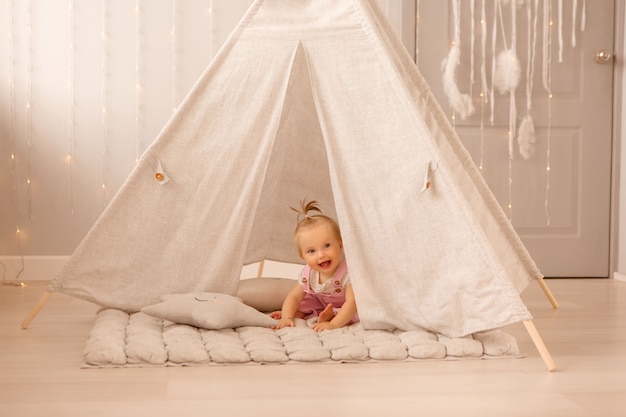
0,279 -> 626,417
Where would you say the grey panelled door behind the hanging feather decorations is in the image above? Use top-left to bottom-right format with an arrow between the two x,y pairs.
417,0 -> 614,277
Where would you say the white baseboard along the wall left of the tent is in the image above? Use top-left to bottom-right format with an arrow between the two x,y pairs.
0,256 -> 69,281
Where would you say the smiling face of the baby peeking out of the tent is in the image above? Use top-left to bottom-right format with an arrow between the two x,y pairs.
298,223 -> 343,278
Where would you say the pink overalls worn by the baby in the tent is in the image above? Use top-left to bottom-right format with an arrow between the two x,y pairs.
298,260 -> 359,323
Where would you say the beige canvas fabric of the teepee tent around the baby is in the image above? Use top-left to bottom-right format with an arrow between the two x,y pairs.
50,0 -> 541,337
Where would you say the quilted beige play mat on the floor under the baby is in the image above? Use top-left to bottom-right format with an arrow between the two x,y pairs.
84,309 -> 521,368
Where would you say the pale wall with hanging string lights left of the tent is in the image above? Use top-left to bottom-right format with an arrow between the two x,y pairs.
0,0 -> 249,256
